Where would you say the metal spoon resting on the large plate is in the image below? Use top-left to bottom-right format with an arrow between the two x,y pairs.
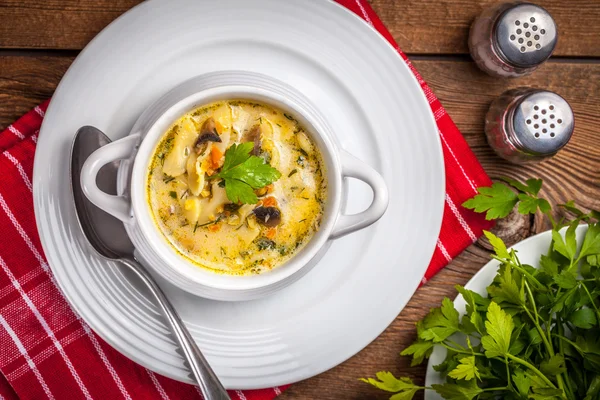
71,126 -> 230,400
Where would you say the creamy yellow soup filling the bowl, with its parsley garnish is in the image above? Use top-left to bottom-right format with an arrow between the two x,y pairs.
147,100 -> 327,275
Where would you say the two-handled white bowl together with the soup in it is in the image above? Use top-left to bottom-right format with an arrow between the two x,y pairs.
82,71 -> 388,300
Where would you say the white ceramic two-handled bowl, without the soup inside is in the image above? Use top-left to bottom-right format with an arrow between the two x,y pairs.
81,71 -> 388,300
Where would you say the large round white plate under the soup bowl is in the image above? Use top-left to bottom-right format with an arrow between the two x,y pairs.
34,0 -> 444,389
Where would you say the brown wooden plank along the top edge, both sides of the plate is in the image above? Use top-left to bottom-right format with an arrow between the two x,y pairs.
0,0 -> 600,56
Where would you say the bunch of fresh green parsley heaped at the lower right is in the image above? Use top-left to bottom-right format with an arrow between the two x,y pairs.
363,179 -> 600,400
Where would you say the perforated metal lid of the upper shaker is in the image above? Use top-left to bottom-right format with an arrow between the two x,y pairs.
493,3 -> 558,68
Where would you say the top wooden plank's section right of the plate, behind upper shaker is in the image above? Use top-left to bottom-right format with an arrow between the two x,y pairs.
370,0 -> 600,57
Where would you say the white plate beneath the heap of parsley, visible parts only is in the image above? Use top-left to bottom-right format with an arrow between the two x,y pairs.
425,225 -> 587,400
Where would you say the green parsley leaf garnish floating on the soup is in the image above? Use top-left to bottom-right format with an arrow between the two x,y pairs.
211,142 -> 281,204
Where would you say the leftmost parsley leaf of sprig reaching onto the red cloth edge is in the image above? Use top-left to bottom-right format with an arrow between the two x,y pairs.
463,183 -> 519,220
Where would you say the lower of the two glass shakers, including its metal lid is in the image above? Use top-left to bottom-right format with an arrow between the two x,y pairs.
485,88 -> 574,164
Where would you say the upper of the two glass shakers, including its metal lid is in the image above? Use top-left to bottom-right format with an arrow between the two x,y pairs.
469,2 -> 558,78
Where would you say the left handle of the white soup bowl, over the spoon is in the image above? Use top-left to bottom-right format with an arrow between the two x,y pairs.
81,135 -> 139,223
